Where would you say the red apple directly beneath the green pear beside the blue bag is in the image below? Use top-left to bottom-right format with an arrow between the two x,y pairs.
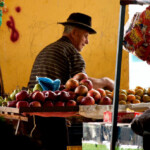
32,91 -> 45,102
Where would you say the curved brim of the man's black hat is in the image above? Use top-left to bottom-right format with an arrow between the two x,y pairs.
58,21 -> 97,34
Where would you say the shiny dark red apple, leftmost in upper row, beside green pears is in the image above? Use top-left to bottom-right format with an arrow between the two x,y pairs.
15,90 -> 29,101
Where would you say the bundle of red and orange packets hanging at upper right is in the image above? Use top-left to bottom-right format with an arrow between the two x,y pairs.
123,6 -> 150,64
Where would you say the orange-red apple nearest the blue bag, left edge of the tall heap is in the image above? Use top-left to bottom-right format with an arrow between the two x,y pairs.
65,78 -> 79,90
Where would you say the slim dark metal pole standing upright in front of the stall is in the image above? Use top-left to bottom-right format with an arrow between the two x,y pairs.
110,5 -> 125,150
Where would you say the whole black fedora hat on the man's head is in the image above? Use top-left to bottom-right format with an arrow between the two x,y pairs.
58,13 -> 96,34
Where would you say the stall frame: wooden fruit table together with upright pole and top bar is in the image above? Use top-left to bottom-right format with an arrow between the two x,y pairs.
0,0 -> 150,150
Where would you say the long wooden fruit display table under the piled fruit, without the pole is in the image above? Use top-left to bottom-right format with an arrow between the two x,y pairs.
0,103 -> 150,134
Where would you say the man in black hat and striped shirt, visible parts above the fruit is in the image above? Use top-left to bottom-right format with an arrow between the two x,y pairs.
28,13 -> 114,90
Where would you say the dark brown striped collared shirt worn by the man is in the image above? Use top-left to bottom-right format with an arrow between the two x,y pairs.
28,36 -> 85,88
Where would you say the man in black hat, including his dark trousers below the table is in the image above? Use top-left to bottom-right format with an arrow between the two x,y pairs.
28,13 -> 114,150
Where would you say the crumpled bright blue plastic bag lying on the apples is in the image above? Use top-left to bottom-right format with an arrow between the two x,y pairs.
36,77 -> 61,91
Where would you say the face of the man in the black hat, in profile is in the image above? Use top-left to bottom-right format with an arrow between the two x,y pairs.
73,28 -> 89,52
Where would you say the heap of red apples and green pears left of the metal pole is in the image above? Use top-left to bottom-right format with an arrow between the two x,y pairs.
2,73 -> 112,108
